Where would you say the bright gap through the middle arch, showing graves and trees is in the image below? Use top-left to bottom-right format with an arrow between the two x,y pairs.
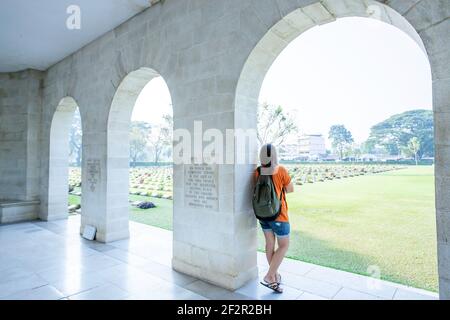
129,77 -> 173,230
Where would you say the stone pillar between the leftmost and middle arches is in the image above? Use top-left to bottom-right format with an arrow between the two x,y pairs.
80,89 -> 129,242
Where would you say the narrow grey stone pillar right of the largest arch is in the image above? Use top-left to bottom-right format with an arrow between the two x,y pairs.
418,13 -> 450,300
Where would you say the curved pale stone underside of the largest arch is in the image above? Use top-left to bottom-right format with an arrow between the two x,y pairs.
235,0 -> 427,121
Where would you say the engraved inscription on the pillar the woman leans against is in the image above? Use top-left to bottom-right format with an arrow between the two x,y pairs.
184,164 -> 219,211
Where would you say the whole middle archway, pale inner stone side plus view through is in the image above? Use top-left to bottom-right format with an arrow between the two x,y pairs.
107,68 -> 173,248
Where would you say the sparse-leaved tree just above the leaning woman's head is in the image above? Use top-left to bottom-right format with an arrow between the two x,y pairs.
257,103 -> 297,146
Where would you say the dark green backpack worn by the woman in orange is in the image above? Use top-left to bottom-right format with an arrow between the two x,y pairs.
252,167 -> 283,221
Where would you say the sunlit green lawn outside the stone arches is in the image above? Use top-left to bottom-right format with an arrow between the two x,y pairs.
70,167 -> 438,291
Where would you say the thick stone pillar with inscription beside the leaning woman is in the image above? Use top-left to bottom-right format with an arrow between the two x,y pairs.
172,106 -> 258,290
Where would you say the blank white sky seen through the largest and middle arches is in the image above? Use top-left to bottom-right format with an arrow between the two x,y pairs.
132,18 -> 432,148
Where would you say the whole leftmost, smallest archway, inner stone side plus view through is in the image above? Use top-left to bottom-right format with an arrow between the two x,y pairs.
47,97 -> 82,220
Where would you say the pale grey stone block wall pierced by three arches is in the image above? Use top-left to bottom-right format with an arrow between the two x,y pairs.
0,0 -> 450,298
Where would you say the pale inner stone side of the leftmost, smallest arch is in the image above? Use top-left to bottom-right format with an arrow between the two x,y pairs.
40,97 -> 78,220
